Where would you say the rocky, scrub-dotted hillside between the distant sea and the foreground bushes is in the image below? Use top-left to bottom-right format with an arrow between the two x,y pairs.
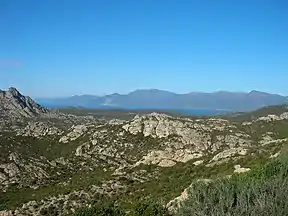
0,89 -> 288,216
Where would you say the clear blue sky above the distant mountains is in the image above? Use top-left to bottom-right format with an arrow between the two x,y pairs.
0,0 -> 288,97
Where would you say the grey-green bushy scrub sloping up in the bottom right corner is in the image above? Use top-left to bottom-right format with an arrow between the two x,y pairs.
179,155 -> 288,216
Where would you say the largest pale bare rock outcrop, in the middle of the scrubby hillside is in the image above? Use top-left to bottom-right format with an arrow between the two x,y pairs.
122,113 -> 251,167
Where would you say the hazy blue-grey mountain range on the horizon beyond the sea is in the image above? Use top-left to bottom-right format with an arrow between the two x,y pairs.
36,89 -> 288,111
